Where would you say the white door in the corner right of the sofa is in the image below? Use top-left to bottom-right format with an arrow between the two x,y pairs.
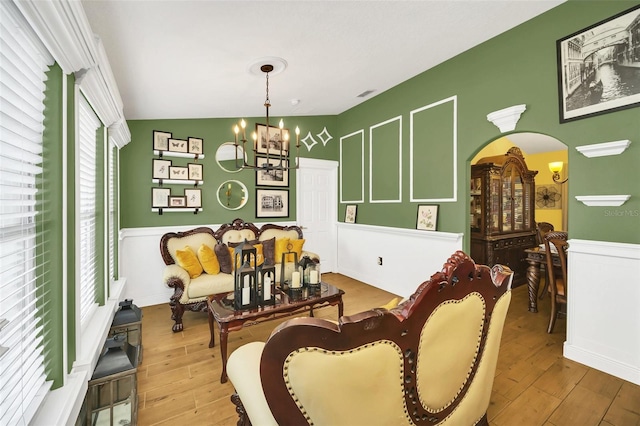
296,158 -> 338,272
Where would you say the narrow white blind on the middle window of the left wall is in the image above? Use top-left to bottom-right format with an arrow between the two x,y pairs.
78,96 -> 100,326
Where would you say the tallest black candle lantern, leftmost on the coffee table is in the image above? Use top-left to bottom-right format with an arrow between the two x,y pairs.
233,240 -> 258,311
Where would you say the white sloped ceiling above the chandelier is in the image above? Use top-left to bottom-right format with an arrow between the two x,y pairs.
82,0 -> 565,120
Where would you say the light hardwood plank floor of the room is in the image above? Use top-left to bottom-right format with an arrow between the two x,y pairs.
134,274 -> 640,426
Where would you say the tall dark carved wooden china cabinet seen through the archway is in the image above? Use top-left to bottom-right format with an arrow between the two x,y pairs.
471,147 -> 538,286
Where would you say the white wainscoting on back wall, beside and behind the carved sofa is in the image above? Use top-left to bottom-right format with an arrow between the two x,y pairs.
119,222 -> 295,307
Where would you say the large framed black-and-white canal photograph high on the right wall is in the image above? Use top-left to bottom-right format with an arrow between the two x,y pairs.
557,5 -> 640,123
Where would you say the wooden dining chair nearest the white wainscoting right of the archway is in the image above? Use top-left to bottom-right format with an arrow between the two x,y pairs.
544,231 -> 568,333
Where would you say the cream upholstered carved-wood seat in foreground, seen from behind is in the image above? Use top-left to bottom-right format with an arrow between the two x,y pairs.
227,252 -> 513,426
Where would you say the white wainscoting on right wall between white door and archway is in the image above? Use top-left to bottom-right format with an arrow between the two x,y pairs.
337,223 -> 464,297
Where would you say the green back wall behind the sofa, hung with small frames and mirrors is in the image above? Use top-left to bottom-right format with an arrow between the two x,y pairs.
119,116 -> 338,228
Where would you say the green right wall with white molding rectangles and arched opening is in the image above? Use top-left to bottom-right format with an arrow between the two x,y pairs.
338,1 -> 640,248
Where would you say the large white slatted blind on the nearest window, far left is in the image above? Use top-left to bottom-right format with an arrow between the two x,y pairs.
0,2 -> 51,425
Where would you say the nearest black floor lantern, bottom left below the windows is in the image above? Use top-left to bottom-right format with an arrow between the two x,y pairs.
86,335 -> 140,426
